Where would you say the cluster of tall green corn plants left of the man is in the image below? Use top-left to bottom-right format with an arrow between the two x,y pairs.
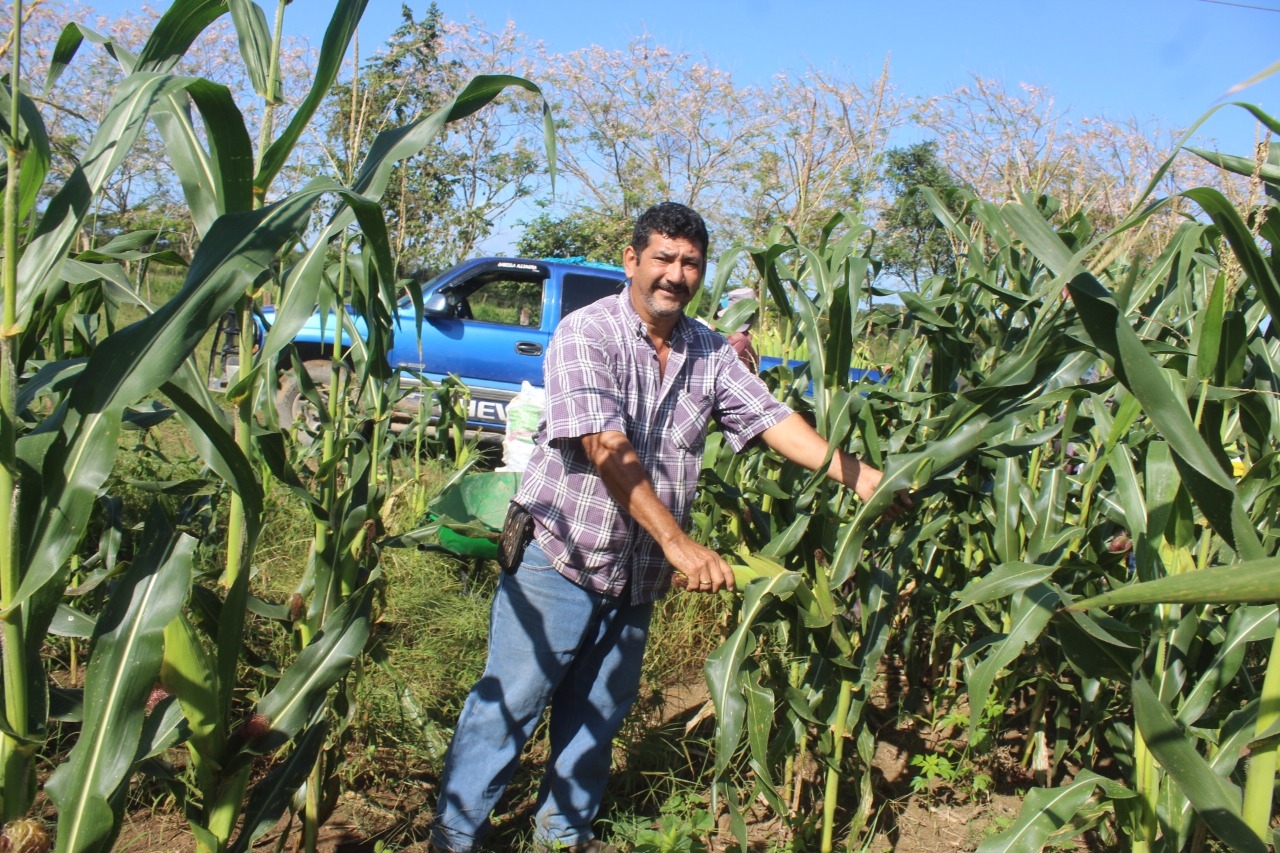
0,0 -> 549,850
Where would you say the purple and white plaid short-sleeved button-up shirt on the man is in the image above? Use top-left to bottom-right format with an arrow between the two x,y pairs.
516,288 -> 791,603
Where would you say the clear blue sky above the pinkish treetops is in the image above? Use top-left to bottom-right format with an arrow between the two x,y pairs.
317,0 -> 1280,154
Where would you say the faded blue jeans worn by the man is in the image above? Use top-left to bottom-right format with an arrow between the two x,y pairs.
431,542 -> 653,853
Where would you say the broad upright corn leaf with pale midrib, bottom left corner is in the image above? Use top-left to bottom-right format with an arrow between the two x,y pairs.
45,508 -> 196,853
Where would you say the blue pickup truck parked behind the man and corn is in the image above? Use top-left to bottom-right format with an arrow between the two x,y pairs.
210,257 -> 879,433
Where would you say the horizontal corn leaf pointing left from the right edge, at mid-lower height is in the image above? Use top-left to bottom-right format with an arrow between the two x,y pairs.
1071,557 -> 1280,610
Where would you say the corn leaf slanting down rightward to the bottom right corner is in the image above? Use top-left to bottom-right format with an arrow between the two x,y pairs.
1133,679 -> 1266,853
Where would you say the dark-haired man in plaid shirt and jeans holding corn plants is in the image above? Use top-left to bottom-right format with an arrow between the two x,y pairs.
433,202 -> 901,853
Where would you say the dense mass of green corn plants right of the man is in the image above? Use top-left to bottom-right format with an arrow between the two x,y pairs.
698,111 -> 1280,850
